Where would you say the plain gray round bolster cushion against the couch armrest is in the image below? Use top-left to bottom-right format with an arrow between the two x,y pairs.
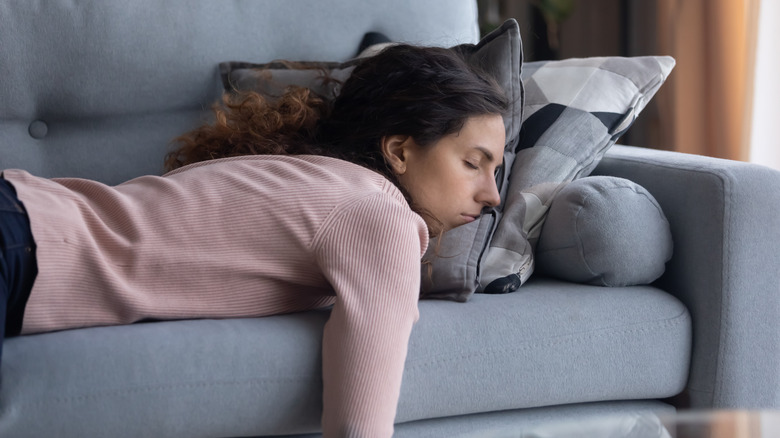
536,176 -> 673,286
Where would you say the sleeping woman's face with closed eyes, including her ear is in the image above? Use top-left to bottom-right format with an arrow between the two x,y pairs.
395,115 -> 505,235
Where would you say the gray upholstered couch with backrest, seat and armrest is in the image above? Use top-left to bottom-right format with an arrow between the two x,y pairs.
0,0 -> 780,437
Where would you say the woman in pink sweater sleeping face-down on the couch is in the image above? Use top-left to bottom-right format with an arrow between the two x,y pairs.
0,45 -> 506,437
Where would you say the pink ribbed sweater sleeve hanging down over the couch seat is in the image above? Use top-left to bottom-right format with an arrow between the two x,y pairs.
314,193 -> 428,437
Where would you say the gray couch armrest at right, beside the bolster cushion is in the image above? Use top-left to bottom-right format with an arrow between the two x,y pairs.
594,146 -> 780,409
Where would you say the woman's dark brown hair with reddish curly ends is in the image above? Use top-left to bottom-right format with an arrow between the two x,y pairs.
165,44 -> 508,184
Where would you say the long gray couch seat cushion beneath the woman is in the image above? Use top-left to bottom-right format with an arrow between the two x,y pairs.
0,278 -> 691,437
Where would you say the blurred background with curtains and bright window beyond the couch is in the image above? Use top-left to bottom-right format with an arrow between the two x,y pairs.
478,0 -> 780,169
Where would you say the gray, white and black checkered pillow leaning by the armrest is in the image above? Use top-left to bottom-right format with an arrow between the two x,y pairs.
479,56 -> 675,293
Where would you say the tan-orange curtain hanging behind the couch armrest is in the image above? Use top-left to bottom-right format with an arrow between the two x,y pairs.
658,0 -> 760,161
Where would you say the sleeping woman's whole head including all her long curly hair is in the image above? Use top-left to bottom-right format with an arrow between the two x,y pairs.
166,45 -> 508,234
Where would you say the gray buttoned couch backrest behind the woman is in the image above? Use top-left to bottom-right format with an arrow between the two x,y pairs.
0,0 -> 479,184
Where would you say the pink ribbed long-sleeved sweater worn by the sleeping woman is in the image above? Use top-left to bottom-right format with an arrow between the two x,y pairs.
3,156 -> 428,437
